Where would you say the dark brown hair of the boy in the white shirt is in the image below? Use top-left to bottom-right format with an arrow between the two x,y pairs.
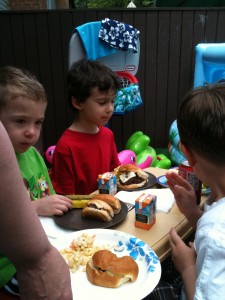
177,83 -> 225,164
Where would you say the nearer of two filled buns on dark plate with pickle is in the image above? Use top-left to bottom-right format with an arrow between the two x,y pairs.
82,200 -> 114,222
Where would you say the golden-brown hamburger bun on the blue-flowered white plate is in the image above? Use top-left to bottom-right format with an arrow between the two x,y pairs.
86,250 -> 139,288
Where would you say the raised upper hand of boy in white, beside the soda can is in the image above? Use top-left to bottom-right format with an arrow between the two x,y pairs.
166,172 -> 203,228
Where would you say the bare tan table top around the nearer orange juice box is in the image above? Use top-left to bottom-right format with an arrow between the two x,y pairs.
113,167 -> 193,261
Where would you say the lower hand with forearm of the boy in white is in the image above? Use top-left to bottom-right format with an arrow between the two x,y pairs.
169,228 -> 196,300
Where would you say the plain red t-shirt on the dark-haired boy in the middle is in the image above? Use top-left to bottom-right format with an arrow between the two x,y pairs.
51,126 -> 120,195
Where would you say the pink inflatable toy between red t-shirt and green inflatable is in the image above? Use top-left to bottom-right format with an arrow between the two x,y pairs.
118,150 -> 152,169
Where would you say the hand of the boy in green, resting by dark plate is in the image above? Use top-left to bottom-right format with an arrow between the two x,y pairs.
32,195 -> 72,216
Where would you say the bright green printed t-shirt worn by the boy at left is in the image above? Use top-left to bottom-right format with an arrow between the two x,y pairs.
0,147 -> 55,287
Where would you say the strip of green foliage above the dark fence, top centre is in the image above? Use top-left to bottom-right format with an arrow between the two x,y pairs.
74,0 -> 153,8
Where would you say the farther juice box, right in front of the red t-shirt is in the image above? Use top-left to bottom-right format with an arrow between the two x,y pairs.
98,172 -> 117,195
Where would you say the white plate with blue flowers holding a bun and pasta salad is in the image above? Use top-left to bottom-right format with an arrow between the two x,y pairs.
54,229 -> 161,300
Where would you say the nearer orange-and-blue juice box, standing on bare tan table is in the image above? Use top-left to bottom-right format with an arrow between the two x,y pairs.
135,193 -> 157,230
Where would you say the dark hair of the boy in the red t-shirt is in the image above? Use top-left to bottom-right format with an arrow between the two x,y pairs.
67,59 -> 120,110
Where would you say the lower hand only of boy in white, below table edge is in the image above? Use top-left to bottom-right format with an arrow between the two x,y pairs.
169,228 -> 196,274
